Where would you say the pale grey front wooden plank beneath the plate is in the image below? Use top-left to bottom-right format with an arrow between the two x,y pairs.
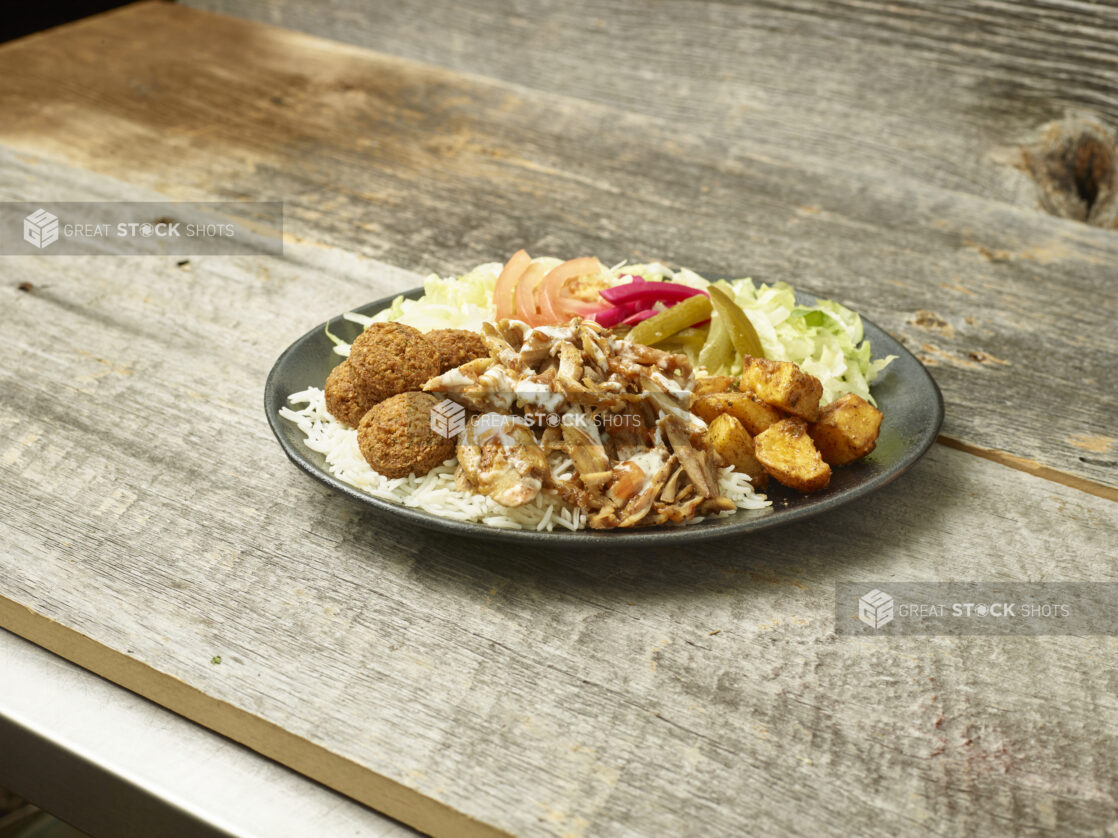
0,198 -> 1118,838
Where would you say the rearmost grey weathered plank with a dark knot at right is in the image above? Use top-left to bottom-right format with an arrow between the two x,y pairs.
186,0 -> 1118,226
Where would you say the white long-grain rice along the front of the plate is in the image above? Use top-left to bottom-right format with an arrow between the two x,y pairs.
280,387 -> 770,532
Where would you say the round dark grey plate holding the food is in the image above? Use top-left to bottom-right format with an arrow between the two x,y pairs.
264,288 -> 944,546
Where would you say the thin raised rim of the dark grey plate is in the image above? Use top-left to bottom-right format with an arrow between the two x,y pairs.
264,288 -> 944,546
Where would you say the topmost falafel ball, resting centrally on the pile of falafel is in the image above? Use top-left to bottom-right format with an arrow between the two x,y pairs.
349,323 -> 438,408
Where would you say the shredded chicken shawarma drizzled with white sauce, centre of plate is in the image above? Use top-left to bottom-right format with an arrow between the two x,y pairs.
424,317 -> 736,528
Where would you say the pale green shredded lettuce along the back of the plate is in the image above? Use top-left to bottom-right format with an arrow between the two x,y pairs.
371,260 -> 896,404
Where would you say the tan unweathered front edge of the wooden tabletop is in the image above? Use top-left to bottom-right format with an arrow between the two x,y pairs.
0,596 -> 503,838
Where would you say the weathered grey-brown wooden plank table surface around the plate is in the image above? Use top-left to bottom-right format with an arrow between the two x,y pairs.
0,0 -> 1118,836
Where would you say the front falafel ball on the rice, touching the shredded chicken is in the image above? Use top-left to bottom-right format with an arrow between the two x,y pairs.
357,392 -> 455,477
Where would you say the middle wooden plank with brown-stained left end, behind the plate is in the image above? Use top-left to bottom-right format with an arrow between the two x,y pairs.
0,3 -> 1118,494
